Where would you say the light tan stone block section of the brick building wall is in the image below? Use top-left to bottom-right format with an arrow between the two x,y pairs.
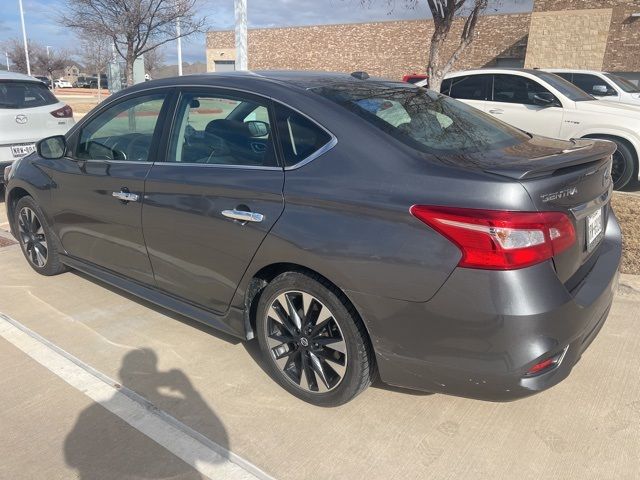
525,8 -> 612,70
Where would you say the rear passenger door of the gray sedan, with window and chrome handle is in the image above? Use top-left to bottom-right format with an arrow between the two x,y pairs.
142,89 -> 284,313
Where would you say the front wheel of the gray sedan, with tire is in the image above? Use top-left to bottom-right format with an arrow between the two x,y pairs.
14,197 -> 67,276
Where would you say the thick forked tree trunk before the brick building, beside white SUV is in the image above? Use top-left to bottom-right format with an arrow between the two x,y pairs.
360,0 -> 520,91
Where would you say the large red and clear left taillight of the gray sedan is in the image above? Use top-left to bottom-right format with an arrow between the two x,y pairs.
410,205 -> 576,270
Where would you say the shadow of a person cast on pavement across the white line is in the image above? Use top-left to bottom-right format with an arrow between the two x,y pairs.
64,349 -> 229,480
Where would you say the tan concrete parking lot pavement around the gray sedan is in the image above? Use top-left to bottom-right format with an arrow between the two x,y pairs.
0,201 -> 640,480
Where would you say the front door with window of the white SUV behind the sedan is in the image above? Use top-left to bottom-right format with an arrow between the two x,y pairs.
486,74 -> 564,138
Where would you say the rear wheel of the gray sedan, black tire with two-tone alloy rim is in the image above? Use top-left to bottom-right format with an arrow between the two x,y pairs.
256,272 -> 376,407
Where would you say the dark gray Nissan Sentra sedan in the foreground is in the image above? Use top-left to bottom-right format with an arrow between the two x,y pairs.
4,72 -> 621,406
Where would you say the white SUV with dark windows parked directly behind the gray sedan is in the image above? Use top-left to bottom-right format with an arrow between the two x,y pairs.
441,68 -> 640,189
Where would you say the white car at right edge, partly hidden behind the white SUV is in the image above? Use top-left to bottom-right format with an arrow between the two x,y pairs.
546,69 -> 640,107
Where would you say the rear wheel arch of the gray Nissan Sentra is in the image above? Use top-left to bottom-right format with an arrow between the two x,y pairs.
244,262 -> 375,351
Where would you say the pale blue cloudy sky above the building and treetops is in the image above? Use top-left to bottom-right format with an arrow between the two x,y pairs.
0,0 -> 533,66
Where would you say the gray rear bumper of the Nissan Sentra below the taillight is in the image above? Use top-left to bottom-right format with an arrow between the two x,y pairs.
349,213 -> 622,401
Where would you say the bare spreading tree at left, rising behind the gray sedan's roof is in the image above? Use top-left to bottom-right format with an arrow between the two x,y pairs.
60,0 -> 206,85
